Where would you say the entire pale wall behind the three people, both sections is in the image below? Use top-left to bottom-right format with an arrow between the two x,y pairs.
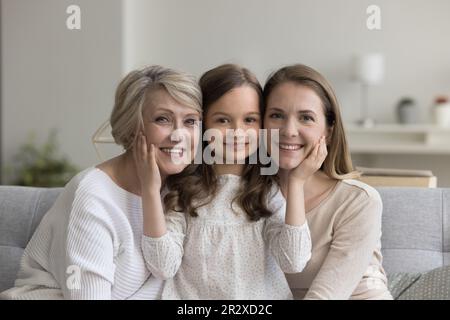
0,0 -> 450,186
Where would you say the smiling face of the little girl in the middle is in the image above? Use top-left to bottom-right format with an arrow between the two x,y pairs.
204,86 -> 261,163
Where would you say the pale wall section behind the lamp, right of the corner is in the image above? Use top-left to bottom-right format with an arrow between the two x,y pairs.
124,0 -> 450,187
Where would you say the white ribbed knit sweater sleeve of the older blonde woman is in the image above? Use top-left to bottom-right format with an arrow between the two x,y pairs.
61,196 -> 115,300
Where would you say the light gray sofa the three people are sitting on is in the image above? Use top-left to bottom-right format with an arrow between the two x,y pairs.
0,186 -> 450,292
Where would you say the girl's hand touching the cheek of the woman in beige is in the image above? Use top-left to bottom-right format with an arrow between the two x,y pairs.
289,136 -> 328,182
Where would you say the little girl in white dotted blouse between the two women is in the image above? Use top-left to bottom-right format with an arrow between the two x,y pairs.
143,65 -> 325,299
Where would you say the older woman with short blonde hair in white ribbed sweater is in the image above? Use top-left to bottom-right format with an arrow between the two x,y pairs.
2,66 -> 201,299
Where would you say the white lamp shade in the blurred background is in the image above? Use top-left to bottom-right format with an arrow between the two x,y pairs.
354,53 -> 384,85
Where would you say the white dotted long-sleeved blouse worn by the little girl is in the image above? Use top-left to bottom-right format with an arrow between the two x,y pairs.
142,174 -> 311,300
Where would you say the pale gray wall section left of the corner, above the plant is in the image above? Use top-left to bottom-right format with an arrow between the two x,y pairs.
1,0 -> 122,181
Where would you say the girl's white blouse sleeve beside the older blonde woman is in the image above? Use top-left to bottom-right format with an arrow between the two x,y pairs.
142,211 -> 187,280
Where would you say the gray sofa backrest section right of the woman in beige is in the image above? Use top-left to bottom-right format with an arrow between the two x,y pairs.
377,187 -> 450,274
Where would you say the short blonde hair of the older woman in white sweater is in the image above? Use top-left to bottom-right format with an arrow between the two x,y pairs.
109,65 -> 202,150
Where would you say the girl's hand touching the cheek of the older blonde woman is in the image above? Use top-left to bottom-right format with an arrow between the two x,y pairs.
133,132 -> 161,194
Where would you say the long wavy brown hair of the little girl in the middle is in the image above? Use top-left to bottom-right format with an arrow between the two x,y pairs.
164,64 -> 274,221
